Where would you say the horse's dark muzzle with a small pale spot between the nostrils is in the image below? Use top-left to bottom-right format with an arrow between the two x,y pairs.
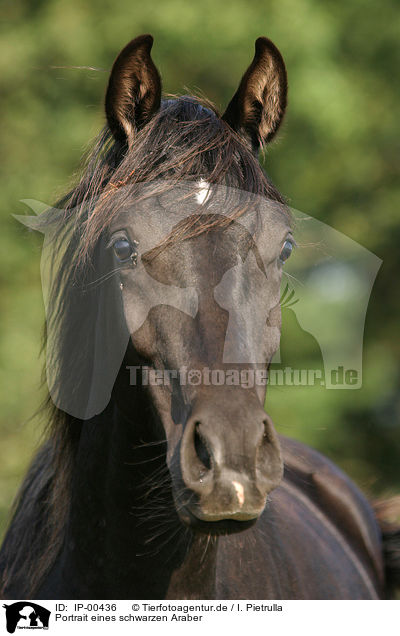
181,402 -> 283,522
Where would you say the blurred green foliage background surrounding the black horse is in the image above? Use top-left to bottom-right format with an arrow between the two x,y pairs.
0,0 -> 400,530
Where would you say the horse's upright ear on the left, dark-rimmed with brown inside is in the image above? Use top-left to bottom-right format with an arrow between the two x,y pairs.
105,35 -> 161,143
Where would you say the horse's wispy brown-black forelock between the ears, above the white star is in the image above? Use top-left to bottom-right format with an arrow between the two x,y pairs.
78,96 -> 284,261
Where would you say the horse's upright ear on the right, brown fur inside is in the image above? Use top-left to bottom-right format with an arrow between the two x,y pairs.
222,38 -> 287,153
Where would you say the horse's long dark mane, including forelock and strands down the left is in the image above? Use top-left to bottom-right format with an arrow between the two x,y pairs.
0,96 -> 284,598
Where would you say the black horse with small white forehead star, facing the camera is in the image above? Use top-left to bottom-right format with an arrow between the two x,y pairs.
0,35 -> 399,599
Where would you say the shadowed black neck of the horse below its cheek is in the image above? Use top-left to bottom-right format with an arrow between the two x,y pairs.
62,398 -> 216,598
